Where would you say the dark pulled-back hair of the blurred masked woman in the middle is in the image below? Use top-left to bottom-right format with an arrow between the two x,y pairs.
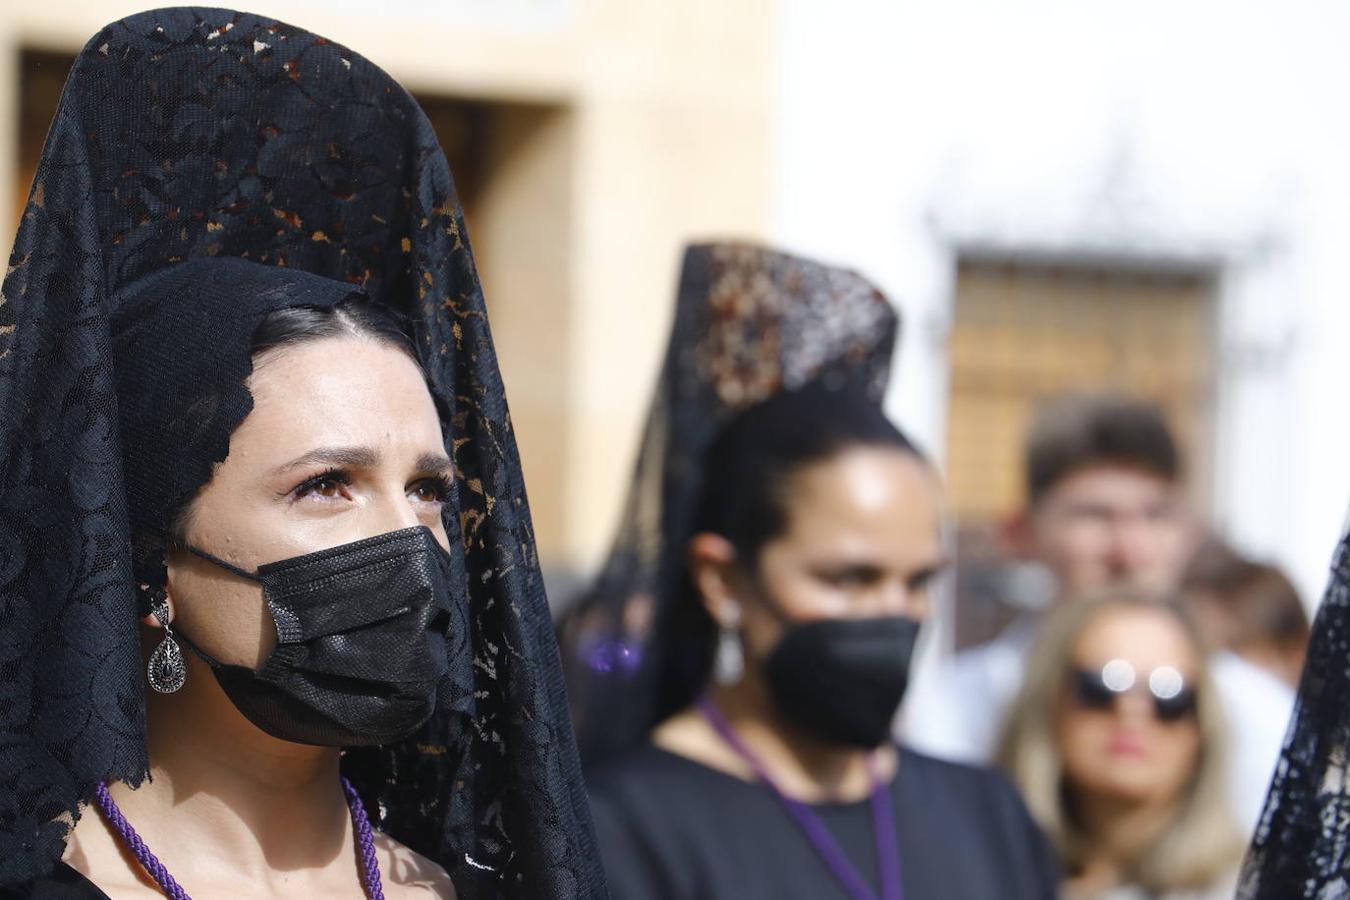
649,383 -> 925,725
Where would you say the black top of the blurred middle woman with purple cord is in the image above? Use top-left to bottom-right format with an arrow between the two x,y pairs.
590,745 -> 1058,900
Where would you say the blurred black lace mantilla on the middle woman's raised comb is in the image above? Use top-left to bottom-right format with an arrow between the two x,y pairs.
562,243 -> 899,765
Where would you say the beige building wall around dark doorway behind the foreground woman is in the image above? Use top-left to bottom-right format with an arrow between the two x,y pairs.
0,0 -> 778,572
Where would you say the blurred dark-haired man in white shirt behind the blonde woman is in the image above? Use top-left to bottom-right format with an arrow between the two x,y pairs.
905,397 -> 1293,824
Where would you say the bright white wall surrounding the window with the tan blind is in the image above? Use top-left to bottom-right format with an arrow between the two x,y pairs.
772,0 -> 1350,612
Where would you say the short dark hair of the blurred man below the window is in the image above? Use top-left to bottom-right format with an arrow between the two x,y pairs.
1026,397 -> 1181,505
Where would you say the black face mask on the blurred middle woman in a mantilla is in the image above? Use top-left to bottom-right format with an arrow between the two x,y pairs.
764,615 -> 919,749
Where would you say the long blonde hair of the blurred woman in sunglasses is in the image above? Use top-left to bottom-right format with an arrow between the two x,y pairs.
998,592 -> 1243,893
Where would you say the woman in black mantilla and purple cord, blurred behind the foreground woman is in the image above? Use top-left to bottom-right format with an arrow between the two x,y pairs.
564,246 -> 1057,900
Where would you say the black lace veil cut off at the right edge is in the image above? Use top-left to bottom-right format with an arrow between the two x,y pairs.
1238,536 -> 1350,900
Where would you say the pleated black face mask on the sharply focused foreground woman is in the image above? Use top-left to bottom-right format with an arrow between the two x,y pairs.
186,526 -> 451,746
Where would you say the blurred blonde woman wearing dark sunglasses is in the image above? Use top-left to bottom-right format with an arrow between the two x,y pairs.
999,594 -> 1241,900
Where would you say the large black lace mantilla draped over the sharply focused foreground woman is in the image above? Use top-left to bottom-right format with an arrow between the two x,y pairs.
0,8 -> 605,900
